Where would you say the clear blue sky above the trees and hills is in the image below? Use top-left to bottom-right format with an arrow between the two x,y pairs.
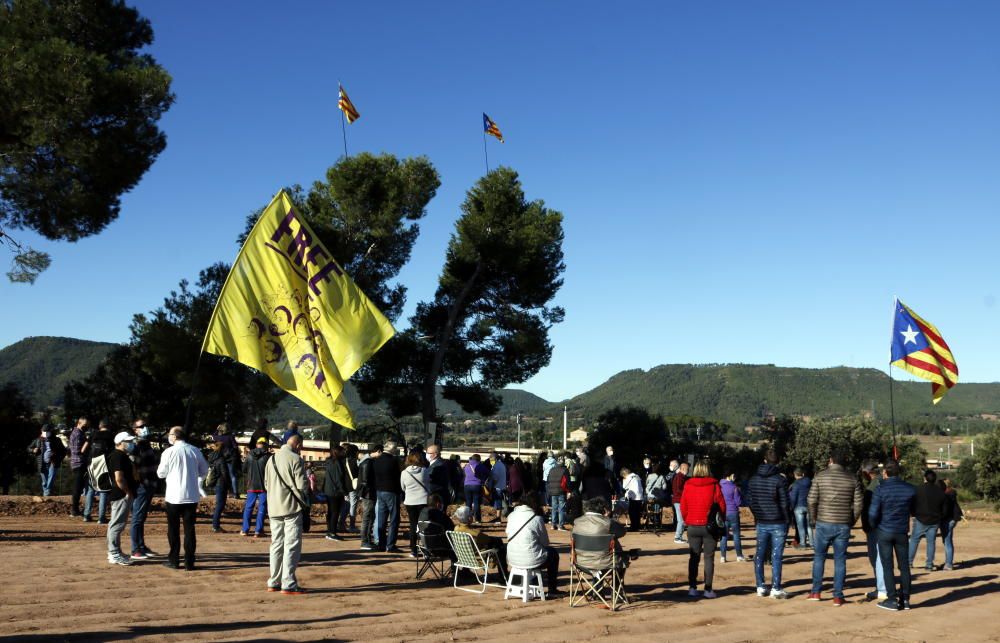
0,1 -> 1000,400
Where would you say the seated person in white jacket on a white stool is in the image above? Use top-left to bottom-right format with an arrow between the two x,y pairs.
507,493 -> 559,595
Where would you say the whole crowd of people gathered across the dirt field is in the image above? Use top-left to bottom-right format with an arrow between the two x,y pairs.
35,418 -> 962,610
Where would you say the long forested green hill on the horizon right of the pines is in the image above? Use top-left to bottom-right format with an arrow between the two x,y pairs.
567,364 -> 1000,426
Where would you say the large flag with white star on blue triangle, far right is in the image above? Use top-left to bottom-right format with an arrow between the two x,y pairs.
889,299 -> 958,404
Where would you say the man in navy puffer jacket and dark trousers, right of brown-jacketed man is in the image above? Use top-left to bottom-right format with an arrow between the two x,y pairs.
868,460 -> 917,610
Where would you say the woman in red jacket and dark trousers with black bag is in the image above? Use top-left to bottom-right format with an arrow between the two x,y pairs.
681,462 -> 726,598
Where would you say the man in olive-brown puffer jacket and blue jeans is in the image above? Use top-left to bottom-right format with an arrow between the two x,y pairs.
808,447 -> 864,607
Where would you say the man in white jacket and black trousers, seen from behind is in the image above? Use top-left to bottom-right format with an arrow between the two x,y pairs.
156,426 -> 208,571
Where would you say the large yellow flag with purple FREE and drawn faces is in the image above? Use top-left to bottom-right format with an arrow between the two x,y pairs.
202,191 -> 396,428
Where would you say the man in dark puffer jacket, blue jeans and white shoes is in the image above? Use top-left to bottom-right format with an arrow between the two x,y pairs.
749,449 -> 789,598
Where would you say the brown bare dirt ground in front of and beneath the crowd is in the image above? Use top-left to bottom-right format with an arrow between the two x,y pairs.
0,497 -> 1000,642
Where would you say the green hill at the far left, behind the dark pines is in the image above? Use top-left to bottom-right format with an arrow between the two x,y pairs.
0,337 -> 115,409
